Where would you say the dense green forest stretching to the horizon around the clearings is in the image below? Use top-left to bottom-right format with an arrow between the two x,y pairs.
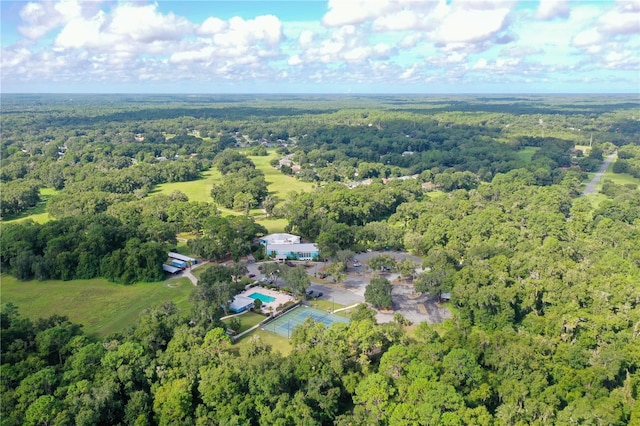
0,95 -> 640,425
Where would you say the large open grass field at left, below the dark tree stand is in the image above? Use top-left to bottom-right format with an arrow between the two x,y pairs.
0,274 -> 193,337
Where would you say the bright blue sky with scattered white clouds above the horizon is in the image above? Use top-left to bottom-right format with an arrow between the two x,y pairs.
0,0 -> 640,93
